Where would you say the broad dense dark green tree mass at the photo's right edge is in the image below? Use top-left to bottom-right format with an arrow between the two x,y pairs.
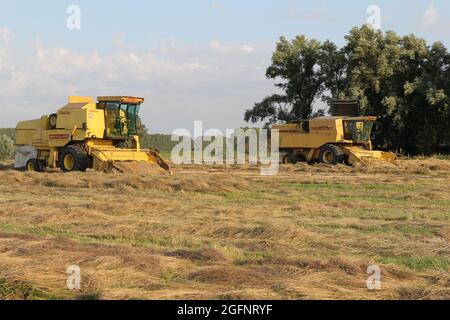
343,26 -> 449,153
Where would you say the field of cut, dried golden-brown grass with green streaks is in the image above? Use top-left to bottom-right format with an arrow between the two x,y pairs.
0,160 -> 450,299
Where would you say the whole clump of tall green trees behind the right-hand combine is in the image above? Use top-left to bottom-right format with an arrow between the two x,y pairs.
245,25 -> 450,154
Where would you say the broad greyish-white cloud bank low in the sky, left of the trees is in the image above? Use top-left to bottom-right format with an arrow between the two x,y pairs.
0,28 -> 273,132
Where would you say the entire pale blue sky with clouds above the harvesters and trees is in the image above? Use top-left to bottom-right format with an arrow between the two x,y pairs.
0,0 -> 450,132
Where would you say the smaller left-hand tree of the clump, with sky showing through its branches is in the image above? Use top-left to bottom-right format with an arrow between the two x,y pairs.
245,36 -> 332,124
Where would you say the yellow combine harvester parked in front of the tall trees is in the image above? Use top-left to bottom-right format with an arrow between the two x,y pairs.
273,117 -> 396,165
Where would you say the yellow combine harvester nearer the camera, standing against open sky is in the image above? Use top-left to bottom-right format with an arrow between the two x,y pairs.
15,97 -> 170,172
